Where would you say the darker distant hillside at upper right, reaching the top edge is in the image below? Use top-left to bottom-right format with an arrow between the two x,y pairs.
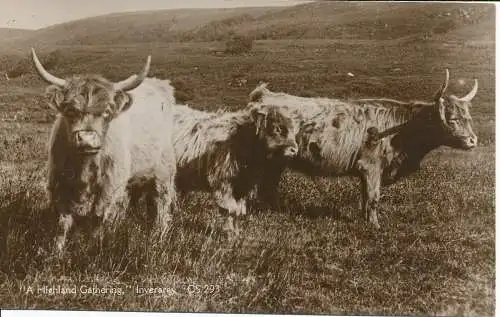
186,2 -> 495,40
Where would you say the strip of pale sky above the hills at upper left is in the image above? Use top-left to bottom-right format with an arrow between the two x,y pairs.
0,0 -> 307,29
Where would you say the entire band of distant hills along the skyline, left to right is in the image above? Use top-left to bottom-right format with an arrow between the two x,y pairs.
0,1 -> 495,52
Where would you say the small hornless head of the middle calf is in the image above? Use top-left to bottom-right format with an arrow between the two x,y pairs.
251,105 -> 298,157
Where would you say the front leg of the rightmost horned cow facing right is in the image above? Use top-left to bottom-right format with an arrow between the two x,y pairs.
358,160 -> 382,229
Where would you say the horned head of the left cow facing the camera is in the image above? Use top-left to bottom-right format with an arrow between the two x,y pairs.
32,49 -> 151,155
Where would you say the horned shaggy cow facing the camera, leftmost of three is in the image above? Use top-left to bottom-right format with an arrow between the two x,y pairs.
32,50 -> 176,254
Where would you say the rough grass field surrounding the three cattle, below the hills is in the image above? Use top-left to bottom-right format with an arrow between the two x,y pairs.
0,34 -> 495,316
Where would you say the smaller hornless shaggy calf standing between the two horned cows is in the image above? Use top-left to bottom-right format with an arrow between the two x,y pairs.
173,105 -> 297,236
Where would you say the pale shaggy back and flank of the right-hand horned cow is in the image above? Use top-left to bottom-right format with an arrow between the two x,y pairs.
248,89 -> 404,175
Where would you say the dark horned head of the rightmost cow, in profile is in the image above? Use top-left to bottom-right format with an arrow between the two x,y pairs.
434,69 -> 478,150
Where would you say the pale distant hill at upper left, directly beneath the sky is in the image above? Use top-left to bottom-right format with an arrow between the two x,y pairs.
0,7 -> 282,50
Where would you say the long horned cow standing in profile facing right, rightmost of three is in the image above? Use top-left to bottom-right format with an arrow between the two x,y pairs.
249,70 -> 478,228
